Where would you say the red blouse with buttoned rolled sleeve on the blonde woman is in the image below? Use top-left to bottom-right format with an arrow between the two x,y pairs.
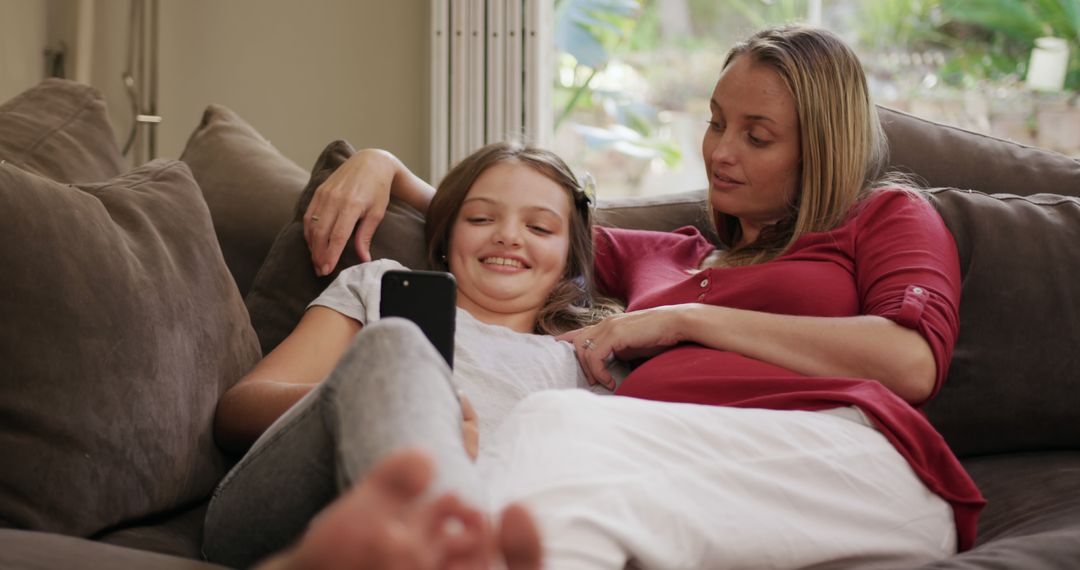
594,190 -> 986,551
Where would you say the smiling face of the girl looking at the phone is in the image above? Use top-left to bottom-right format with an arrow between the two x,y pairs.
447,161 -> 573,331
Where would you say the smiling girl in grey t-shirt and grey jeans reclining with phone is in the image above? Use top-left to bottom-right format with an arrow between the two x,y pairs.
204,144 -> 616,566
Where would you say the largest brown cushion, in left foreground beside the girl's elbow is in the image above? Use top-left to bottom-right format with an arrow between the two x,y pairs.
0,161 -> 258,535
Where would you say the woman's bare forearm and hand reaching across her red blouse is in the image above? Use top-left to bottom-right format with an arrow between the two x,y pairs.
565,303 -> 936,404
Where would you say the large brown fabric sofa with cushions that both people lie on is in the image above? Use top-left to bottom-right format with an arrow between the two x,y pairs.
0,79 -> 1080,569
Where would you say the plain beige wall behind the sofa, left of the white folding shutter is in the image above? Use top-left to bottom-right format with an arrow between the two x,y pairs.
0,0 -> 430,176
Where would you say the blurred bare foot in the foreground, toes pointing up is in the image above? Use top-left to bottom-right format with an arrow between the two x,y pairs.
251,450 -> 541,570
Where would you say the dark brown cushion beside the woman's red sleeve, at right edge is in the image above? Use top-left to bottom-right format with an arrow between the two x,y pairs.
926,189 -> 1080,456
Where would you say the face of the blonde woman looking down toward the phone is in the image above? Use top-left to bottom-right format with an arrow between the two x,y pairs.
702,55 -> 801,245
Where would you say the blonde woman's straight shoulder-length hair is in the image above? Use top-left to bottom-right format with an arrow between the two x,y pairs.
710,26 -> 889,266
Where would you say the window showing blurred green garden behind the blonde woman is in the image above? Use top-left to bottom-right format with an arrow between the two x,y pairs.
552,0 -> 1080,198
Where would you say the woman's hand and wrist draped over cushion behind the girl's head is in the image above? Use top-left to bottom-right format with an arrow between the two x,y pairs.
303,149 -> 435,275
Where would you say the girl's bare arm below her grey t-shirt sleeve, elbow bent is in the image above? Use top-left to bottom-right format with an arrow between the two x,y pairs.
214,307 -> 361,452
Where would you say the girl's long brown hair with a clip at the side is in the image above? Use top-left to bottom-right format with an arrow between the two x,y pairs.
424,143 -> 621,335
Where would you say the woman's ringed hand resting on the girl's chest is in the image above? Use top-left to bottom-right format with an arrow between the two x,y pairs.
557,304 -> 690,390
